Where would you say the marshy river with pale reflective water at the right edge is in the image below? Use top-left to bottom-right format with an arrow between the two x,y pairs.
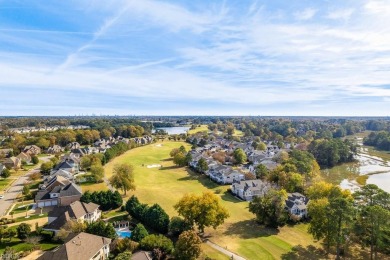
321,136 -> 390,192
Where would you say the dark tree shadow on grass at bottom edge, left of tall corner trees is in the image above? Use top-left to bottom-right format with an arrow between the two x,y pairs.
280,245 -> 327,260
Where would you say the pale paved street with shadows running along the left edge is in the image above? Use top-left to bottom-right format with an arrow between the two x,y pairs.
0,156 -> 52,216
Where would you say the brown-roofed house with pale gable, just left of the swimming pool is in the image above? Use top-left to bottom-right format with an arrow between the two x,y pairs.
43,201 -> 102,232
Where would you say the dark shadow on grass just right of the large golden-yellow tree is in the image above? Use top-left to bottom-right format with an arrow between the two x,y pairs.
224,219 -> 279,239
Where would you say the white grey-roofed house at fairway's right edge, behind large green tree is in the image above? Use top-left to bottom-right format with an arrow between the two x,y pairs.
231,180 -> 272,201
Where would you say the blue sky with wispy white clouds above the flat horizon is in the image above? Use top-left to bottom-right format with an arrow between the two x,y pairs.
0,0 -> 390,116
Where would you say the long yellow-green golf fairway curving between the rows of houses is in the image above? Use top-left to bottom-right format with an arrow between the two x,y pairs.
105,141 -> 317,259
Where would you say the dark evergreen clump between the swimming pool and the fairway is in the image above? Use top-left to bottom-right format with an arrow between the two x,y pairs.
126,196 -> 169,234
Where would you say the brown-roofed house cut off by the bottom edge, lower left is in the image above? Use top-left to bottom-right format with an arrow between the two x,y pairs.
37,232 -> 111,260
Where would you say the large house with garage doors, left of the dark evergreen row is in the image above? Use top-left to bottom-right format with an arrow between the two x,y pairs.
35,180 -> 83,207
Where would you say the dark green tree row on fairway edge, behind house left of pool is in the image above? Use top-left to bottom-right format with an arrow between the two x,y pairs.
80,190 -> 123,211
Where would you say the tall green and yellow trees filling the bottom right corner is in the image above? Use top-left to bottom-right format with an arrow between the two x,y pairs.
307,182 -> 390,259
